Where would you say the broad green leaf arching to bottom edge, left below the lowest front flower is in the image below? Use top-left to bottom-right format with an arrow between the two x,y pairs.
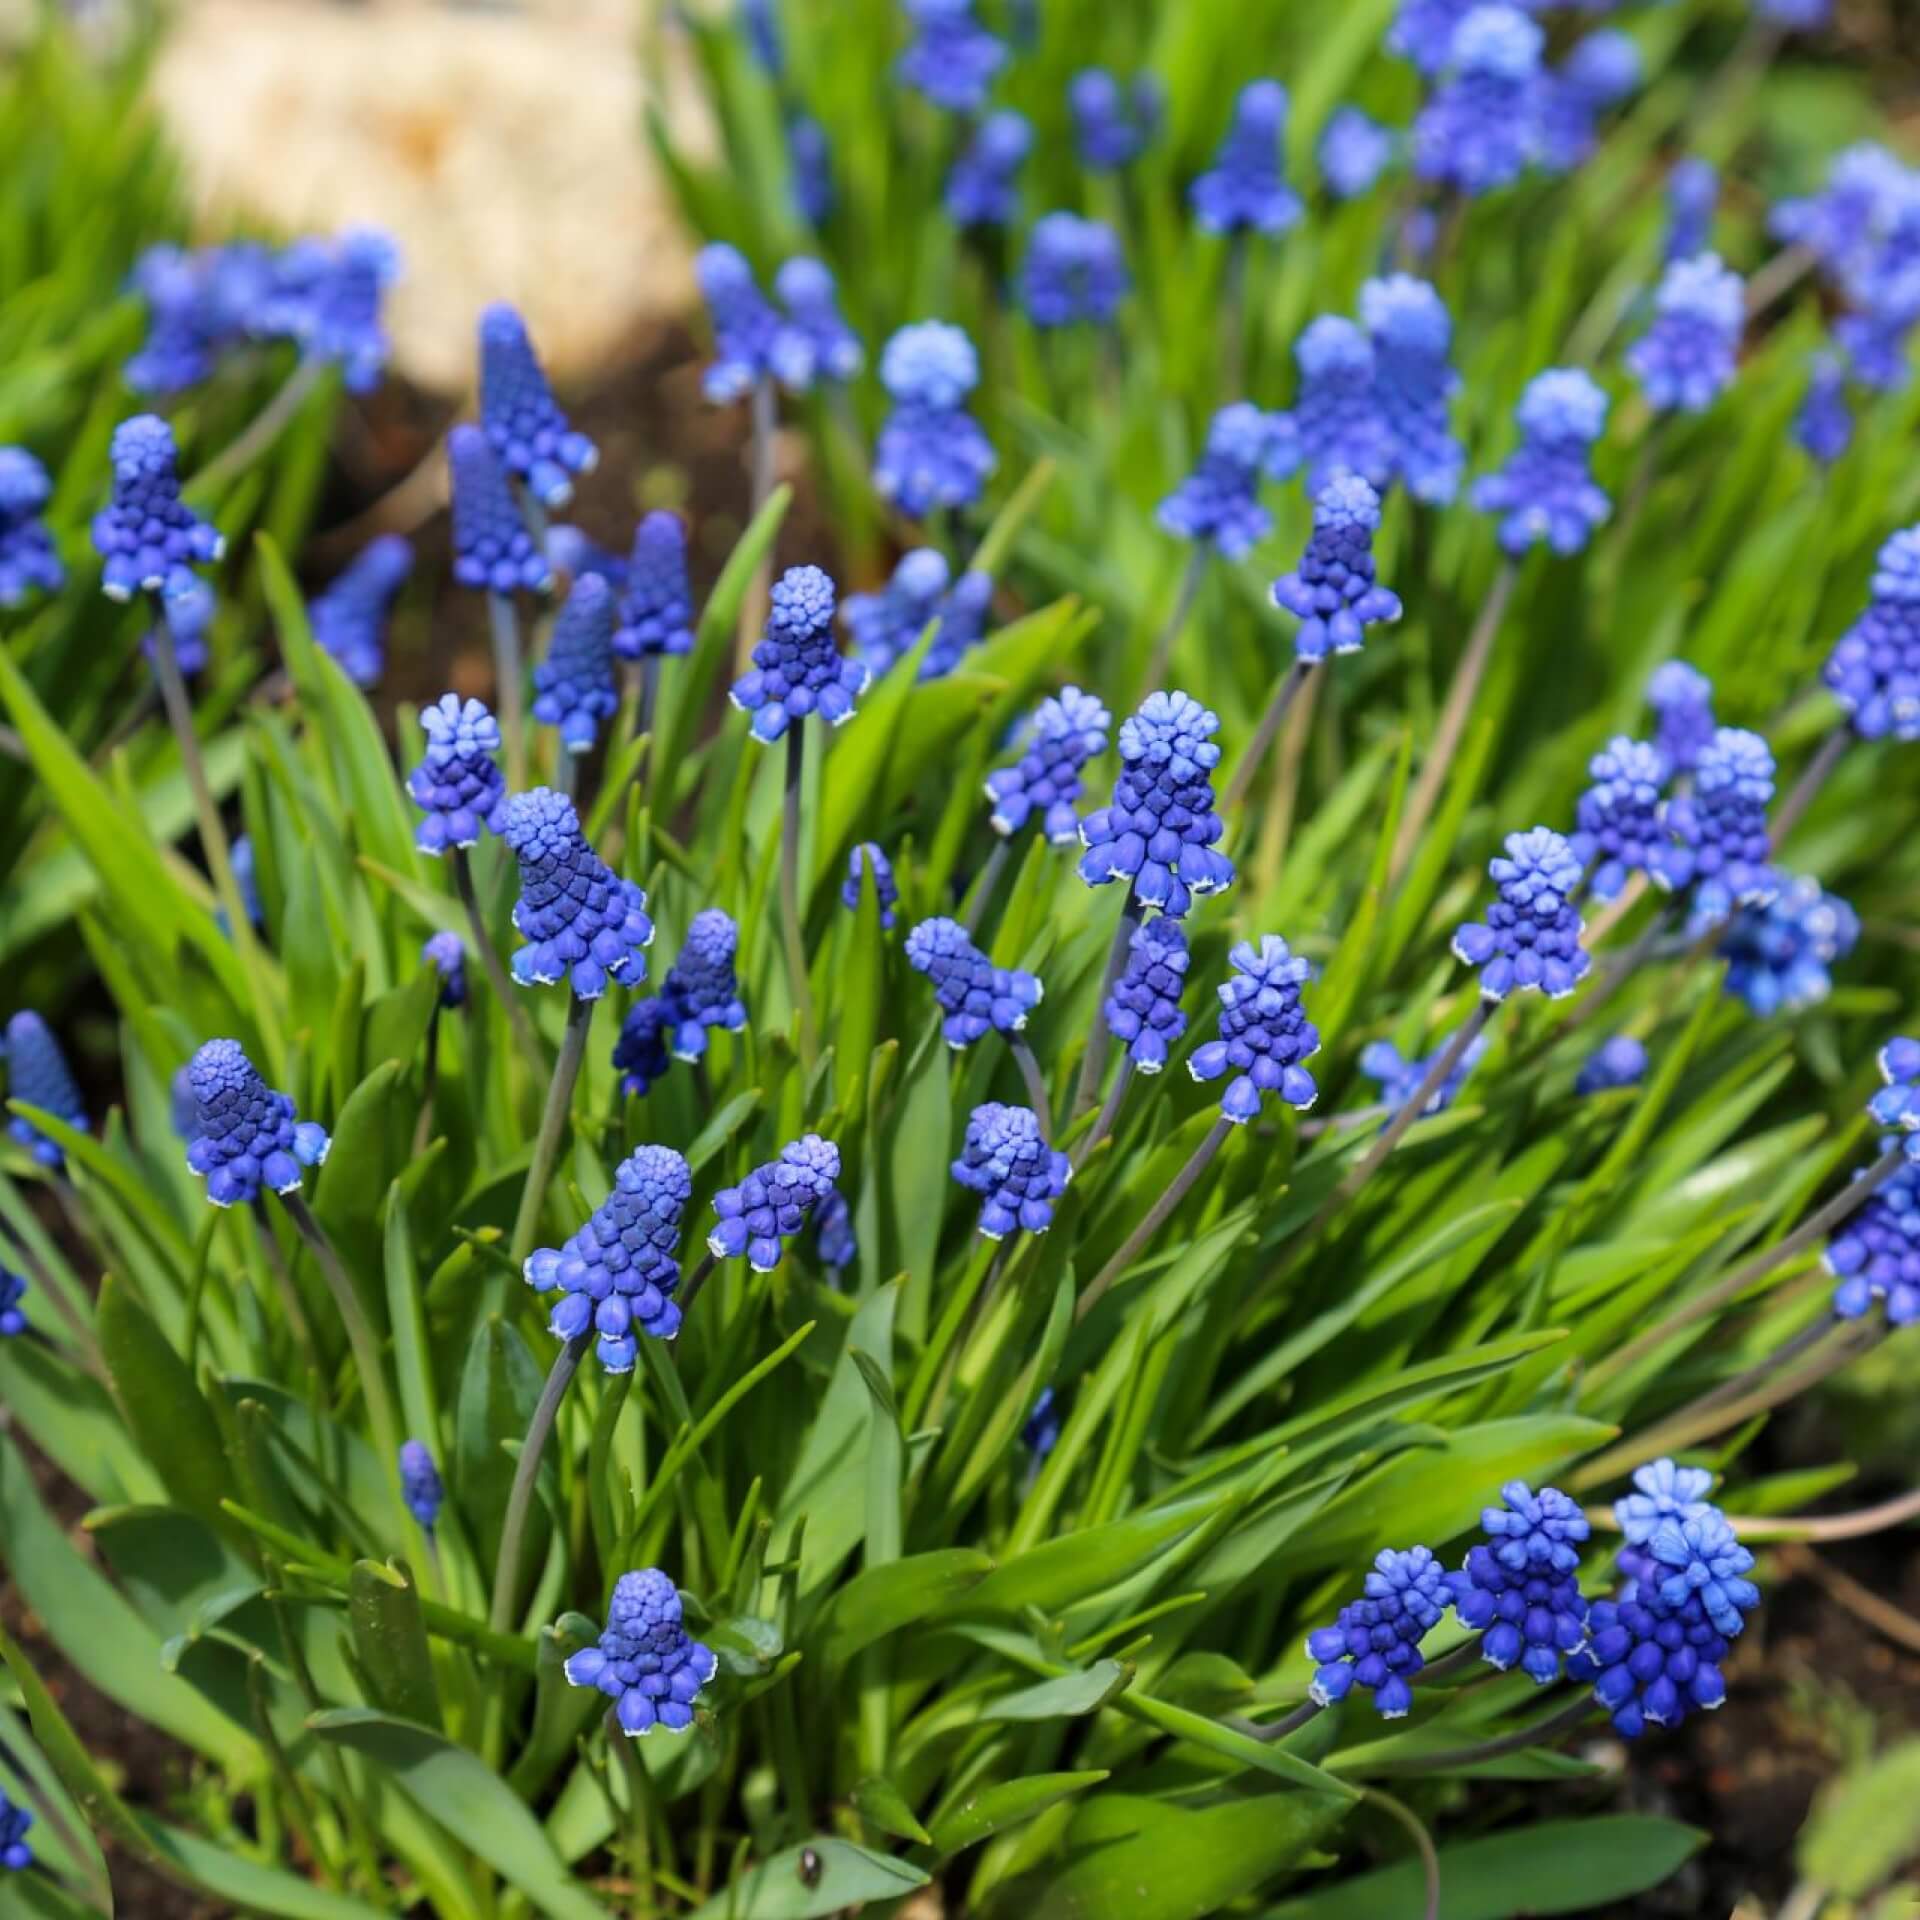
307,1707 -> 607,1920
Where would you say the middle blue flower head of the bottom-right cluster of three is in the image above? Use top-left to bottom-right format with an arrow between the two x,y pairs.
1450,1480 -> 1590,1686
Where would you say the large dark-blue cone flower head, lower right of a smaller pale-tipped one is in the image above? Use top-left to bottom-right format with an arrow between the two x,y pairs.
499,787 -> 653,1000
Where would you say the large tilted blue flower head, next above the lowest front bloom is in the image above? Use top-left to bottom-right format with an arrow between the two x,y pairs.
524,1146 -> 693,1373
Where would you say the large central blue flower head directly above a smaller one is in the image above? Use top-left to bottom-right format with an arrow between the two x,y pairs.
1079,693 -> 1233,920
